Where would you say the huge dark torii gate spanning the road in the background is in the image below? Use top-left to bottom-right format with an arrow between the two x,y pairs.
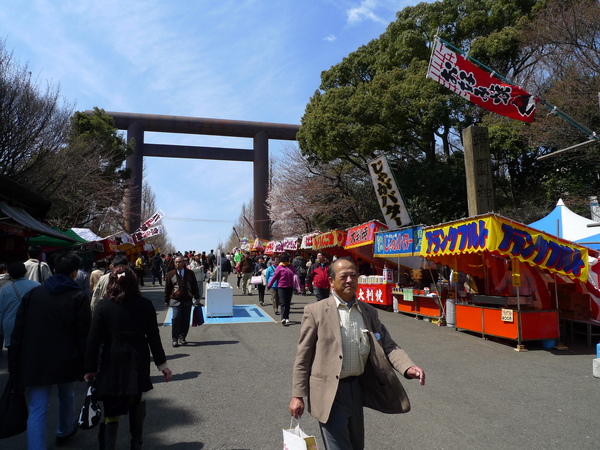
92,111 -> 300,239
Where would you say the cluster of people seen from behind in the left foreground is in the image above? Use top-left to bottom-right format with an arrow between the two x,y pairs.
0,246 -> 172,450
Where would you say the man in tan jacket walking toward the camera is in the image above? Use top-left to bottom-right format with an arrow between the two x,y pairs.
290,258 -> 425,450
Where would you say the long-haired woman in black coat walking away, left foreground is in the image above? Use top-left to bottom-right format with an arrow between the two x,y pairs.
85,266 -> 171,449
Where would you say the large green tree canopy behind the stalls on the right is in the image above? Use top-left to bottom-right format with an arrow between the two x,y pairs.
298,0 -> 600,223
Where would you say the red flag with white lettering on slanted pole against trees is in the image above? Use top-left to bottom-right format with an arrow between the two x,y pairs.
427,37 -> 537,122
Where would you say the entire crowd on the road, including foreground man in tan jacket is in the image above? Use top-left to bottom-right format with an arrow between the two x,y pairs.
0,247 -> 425,449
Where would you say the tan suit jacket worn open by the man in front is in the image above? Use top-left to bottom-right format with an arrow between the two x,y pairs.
292,296 -> 415,423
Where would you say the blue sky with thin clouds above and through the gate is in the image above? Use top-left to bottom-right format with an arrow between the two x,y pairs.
0,0 -> 418,251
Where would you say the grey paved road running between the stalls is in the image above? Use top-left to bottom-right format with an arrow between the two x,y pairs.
0,277 -> 600,450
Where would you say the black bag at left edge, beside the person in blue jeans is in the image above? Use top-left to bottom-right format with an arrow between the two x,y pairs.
0,375 -> 29,439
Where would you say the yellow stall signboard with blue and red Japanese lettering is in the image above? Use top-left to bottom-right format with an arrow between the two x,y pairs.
420,214 -> 588,283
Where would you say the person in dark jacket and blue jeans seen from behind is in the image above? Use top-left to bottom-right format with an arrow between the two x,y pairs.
8,253 -> 91,450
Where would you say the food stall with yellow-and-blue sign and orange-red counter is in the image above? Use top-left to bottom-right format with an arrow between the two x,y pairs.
420,214 -> 588,350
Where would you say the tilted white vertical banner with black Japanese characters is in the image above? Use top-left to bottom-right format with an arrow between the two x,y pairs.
367,155 -> 412,230
